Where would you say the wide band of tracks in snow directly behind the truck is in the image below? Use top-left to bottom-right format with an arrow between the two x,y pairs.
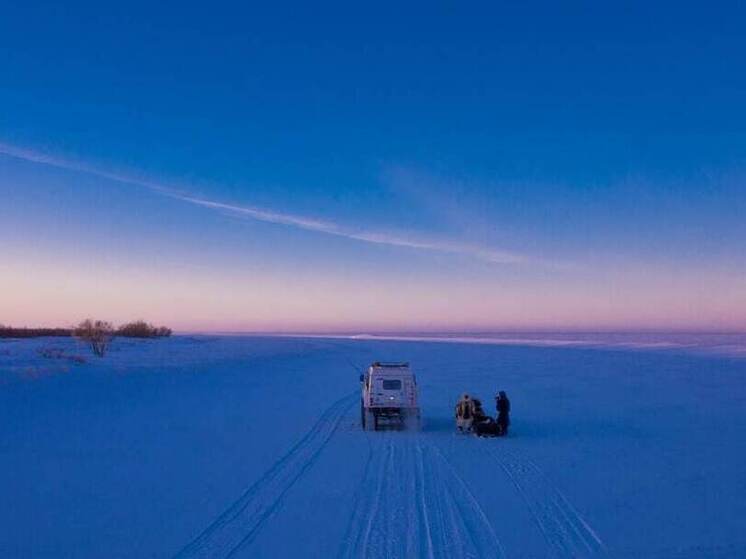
338,433 -> 505,559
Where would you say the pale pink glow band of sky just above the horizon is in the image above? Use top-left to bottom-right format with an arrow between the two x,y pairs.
0,253 -> 746,332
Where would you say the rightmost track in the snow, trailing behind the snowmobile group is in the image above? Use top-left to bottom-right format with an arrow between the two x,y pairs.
485,447 -> 608,559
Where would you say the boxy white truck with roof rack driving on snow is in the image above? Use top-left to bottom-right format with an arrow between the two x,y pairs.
360,361 -> 420,431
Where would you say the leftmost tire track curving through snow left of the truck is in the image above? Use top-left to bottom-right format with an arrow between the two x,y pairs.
175,391 -> 359,559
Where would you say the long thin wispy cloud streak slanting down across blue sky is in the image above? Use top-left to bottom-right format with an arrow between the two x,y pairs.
0,142 -> 530,264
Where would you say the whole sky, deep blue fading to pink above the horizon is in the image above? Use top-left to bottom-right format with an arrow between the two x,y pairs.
0,1 -> 746,333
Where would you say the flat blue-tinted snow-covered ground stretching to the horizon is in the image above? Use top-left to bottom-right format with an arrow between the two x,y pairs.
0,335 -> 746,559
